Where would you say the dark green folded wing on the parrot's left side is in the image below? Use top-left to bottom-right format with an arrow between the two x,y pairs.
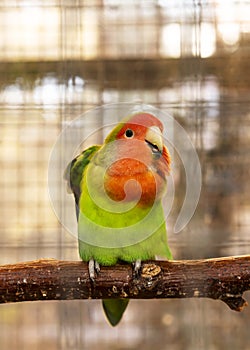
64,145 -> 101,218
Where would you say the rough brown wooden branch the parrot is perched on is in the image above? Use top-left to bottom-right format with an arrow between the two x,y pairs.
0,256 -> 250,311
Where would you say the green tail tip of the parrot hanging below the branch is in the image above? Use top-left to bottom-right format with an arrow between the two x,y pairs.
102,299 -> 129,326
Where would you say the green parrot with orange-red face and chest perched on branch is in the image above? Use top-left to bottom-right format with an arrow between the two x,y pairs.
65,111 -> 172,326
